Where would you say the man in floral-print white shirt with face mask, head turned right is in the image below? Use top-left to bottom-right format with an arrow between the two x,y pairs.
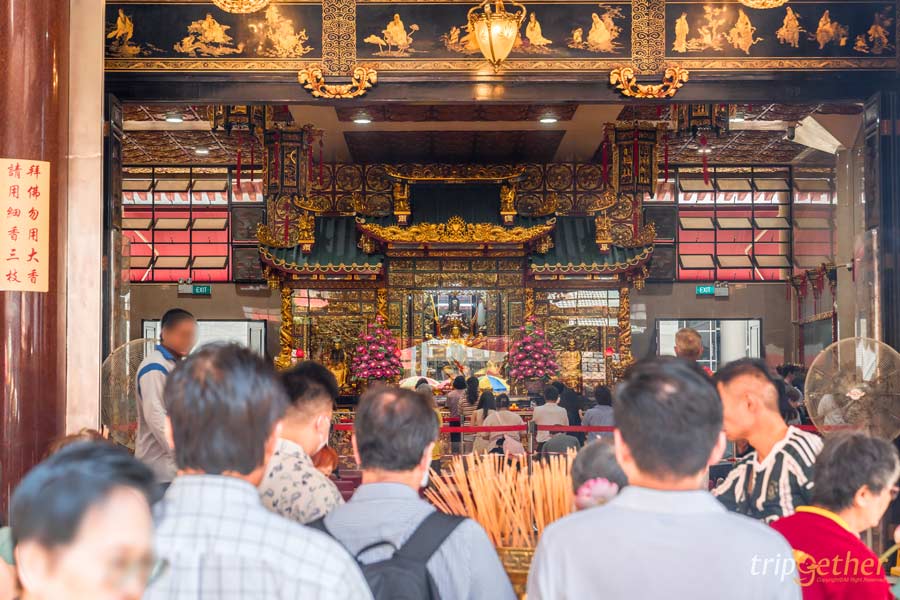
259,360 -> 344,524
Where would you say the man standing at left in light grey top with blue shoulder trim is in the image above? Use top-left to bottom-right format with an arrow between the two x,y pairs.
134,308 -> 197,487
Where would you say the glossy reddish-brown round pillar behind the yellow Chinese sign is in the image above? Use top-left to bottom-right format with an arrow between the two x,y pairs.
0,0 -> 69,520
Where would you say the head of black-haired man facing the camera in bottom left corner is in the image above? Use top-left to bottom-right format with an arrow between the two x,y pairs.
10,442 -> 157,600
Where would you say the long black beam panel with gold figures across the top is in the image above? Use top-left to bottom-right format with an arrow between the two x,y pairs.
103,0 -> 898,73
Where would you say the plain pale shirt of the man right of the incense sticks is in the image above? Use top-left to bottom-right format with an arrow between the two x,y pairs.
528,486 -> 801,600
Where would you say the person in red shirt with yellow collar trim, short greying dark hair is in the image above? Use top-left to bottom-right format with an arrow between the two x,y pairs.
772,432 -> 900,600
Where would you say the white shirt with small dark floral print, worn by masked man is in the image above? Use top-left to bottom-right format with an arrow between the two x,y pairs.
259,439 -> 344,525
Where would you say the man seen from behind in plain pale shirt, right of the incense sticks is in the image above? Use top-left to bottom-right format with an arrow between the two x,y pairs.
528,357 -> 800,600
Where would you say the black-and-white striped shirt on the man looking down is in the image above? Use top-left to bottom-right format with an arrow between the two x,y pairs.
713,427 -> 822,523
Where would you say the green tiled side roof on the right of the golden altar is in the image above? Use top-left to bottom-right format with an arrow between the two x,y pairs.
531,217 -> 653,275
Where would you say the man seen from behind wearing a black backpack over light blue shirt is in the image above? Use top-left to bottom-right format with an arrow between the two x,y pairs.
309,386 -> 516,600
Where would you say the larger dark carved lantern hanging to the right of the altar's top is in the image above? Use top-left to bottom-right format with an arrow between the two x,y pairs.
606,121 -> 668,198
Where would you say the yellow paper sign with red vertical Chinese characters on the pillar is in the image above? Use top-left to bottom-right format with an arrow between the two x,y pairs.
0,158 -> 50,292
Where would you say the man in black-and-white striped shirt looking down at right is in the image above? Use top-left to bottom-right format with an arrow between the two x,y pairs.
713,358 -> 822,523
